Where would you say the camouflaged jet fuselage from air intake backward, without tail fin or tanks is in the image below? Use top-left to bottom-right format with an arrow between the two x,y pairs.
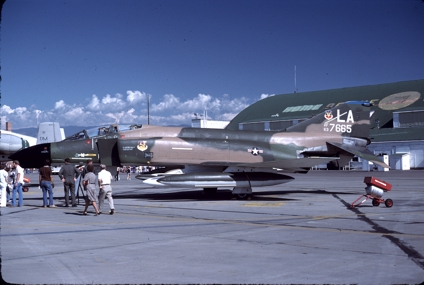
100,123 -> 342,167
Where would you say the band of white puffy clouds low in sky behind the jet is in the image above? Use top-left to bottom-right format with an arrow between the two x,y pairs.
0,90 -> 258,129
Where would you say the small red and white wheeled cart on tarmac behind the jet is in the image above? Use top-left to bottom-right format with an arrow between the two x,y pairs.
350,176 -> 393,208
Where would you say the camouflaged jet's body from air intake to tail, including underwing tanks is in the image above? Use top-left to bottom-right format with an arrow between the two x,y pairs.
97,101 -> 389,195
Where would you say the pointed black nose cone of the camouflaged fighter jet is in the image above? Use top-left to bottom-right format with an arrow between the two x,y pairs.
9,143 -> 51,168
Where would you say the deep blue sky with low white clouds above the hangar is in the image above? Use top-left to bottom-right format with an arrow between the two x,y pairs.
0,0 -> 424,129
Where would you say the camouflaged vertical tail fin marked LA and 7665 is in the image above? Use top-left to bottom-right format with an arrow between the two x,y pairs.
286,101 -> 371,139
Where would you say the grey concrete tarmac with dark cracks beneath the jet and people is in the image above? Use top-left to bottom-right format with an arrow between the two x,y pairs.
0,170 -> 424,284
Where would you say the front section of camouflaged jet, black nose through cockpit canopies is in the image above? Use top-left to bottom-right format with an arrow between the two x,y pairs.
9,124 -> 141,168
